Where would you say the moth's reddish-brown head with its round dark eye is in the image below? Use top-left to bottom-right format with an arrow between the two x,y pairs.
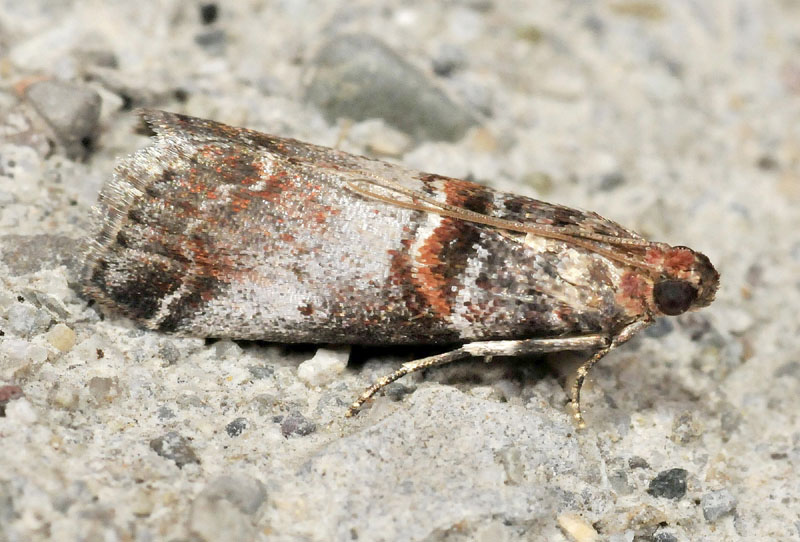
653,246 -> 719,316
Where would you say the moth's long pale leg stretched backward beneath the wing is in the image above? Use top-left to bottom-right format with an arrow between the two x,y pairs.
345,335 -> 610,417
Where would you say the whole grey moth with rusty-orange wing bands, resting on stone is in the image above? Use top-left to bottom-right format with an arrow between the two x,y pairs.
83,110 -> 719,425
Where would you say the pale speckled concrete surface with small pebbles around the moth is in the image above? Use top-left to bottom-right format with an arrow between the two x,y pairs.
0,0 -> 800,542
